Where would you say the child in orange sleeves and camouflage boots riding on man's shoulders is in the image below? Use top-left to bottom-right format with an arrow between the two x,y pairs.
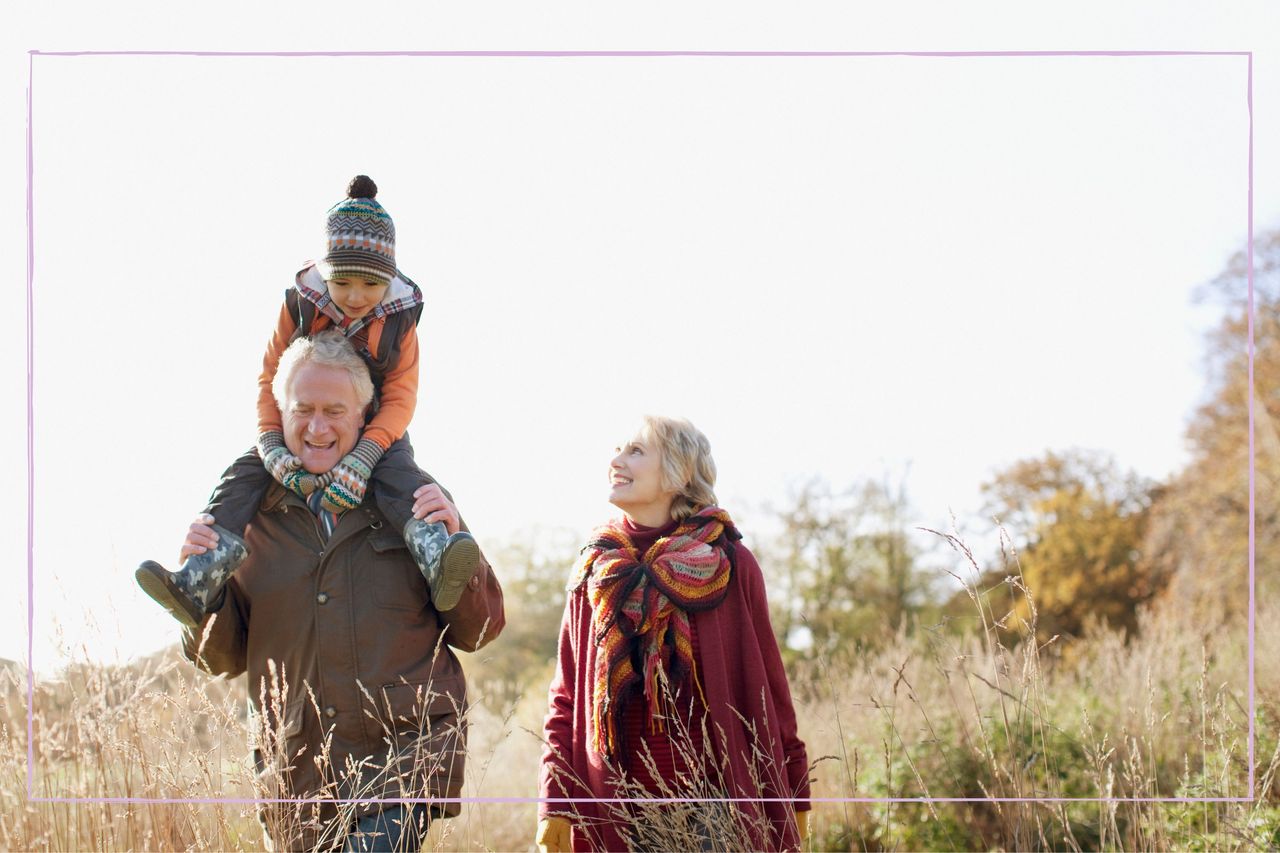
136,175 -> 480,628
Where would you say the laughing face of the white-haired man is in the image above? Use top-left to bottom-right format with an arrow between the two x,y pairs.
282,364 -> 365,474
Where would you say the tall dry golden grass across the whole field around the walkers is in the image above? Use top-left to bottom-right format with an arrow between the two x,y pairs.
0,527 -> 1280,850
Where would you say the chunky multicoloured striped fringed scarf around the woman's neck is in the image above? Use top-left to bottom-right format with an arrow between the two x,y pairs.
570,506 -> 742,758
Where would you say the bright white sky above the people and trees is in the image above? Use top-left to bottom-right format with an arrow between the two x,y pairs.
0,4 -> 1280,670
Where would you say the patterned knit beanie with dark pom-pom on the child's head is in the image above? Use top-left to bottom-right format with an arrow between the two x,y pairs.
319,174 -> 396,282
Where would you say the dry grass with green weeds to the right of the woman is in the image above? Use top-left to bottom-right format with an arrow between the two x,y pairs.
792,534 -> 1280,850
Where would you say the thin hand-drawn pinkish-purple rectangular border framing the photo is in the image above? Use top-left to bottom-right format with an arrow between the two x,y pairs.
27,50 -> 1257,804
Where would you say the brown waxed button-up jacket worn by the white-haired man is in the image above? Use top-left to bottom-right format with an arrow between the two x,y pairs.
183,484 -> 504,849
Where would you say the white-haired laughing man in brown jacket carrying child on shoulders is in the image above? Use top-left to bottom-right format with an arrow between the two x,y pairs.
157,332 -> 504,850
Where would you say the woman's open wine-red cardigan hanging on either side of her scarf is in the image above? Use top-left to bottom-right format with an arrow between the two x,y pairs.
538,542 -> 809,850
